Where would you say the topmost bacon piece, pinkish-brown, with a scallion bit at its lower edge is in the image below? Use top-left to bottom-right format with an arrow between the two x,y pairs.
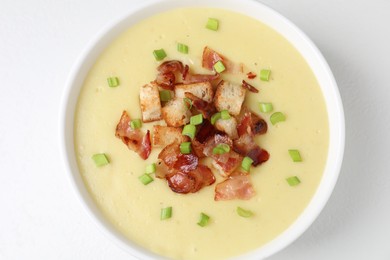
202,46 -> 243,74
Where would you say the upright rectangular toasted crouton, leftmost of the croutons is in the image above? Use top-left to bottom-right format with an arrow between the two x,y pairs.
139,83 -> 161,122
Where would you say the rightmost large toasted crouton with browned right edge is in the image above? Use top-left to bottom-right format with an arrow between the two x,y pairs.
214,81 -> 246,116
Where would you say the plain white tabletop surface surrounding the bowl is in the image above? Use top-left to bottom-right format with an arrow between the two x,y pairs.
0,0 -> 390,260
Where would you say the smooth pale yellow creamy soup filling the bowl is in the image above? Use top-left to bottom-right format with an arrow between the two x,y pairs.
74,8 -> 329,259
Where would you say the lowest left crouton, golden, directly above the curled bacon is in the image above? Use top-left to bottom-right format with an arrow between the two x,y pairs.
153,125 -> 189,147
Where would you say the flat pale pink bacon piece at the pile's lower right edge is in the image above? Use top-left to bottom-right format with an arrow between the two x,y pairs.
214,172 -> 255,201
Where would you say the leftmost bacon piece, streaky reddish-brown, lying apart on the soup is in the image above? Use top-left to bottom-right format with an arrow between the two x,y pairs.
115,111 -> 152,160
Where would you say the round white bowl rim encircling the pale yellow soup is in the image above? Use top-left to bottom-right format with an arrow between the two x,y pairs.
60,0 -> 345,259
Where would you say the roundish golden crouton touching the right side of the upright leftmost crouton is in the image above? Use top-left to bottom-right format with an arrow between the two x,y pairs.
162,98 -> 191,127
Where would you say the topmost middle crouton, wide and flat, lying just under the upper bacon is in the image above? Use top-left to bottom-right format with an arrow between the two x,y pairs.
175,82 -> 214,103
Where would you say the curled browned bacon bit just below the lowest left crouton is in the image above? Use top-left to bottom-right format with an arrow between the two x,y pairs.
158,143 -> 199,173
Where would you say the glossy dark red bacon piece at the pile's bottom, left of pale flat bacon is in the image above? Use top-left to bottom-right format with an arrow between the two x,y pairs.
166,164 -> 215,194
